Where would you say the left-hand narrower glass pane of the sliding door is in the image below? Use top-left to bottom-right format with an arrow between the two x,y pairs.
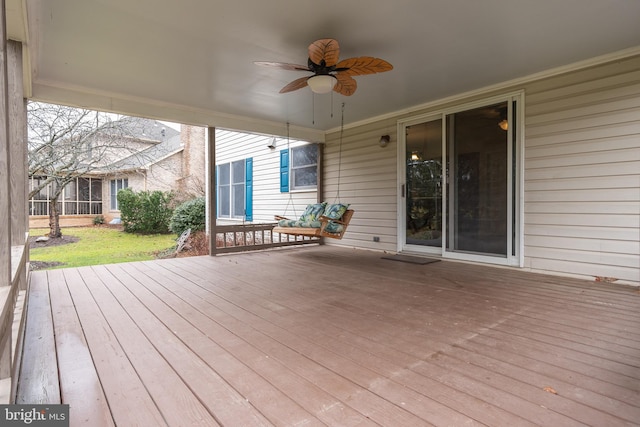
405,119 -> 442,248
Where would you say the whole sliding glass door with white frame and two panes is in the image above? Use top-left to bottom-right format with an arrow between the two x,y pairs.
399,97 -> 520,264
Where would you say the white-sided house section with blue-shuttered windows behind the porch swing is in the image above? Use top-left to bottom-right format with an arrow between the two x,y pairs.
215,129 -> 322,224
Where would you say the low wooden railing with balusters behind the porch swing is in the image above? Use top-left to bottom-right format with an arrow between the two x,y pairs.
212,223 -> 320,255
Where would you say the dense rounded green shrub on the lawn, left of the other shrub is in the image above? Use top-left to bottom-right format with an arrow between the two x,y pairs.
118,188 -> 173,234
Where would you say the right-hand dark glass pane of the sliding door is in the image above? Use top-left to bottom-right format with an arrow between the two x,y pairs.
446,102 -> 509,256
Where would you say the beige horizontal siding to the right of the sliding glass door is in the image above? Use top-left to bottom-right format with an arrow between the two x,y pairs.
524,58 -> 640,283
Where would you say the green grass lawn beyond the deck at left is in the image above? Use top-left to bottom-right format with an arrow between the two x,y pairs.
29,227 -> 176,268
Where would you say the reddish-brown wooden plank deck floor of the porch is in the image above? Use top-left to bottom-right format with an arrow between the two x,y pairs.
19,246 -> 640,427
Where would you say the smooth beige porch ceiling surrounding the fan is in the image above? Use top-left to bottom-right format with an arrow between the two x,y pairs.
7,0 -> 640,135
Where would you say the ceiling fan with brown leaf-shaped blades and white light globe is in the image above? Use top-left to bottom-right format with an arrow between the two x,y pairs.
255,39 -> 393,96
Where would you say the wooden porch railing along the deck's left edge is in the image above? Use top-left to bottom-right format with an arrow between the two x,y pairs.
0,240 -> 29,404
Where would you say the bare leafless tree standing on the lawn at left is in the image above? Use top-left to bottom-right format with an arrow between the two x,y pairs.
27,102 -> 164,238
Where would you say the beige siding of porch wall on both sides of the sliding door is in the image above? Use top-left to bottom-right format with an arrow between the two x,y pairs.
324,57 -> 640,284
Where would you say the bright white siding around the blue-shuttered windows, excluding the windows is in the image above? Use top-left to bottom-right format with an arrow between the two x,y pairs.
216,129 -> 318,223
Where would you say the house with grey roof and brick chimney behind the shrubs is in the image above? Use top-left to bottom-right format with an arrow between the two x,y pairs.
29,117 -> 205,227
